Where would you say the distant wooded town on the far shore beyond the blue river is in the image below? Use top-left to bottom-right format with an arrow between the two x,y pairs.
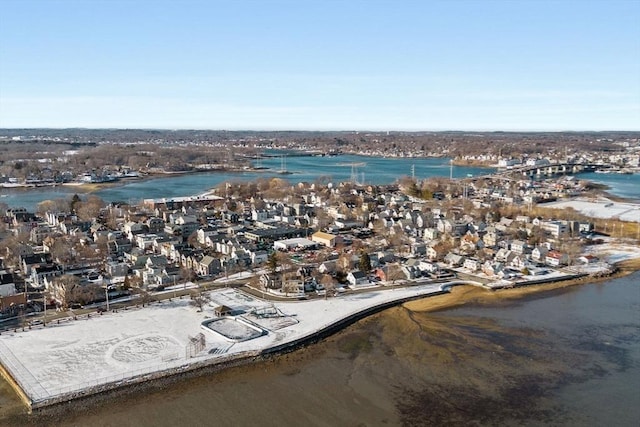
0,129 -> 640,187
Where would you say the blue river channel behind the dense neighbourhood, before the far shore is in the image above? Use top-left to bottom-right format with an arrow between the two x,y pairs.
0,155 -> 484,210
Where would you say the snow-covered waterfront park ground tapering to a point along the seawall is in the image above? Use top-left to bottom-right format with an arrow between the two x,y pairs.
0,284 -> 443,406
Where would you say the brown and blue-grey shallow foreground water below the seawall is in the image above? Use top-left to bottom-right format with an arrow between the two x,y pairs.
0,273 -> 640,427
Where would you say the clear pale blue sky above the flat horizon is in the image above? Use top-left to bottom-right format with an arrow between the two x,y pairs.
0,0 -> 640,131
